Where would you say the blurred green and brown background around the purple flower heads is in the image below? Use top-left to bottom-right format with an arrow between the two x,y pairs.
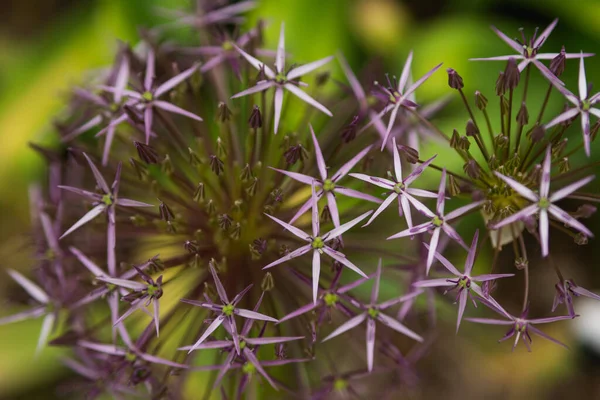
0,0 -> 600,399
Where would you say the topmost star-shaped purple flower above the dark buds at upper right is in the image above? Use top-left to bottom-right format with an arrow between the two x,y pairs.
470,18 -> 593,74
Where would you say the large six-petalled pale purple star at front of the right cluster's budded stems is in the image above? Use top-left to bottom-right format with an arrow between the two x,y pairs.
491,146 -> 595,257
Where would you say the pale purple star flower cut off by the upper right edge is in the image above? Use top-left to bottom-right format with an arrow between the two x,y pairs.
546,53 -> 600,157
